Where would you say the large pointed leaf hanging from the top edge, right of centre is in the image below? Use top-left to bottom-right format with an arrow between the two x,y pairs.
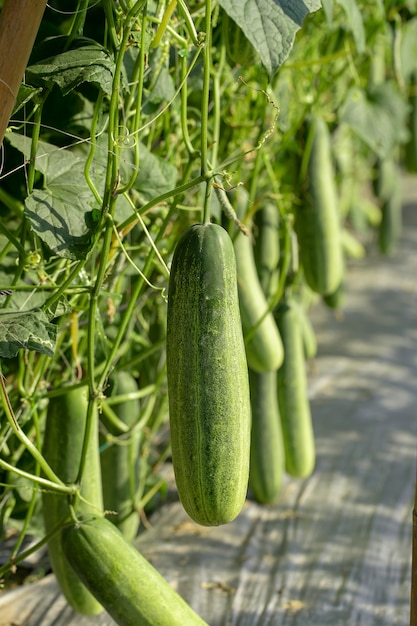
219,0 -> 321,76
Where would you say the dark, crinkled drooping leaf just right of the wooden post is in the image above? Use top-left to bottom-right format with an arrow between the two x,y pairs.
26,44 -> 114,95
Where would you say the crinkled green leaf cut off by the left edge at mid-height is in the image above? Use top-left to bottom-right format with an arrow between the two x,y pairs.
0,309 -> 57,359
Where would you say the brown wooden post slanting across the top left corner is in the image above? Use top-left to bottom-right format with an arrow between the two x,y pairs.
0,0 -> 47,144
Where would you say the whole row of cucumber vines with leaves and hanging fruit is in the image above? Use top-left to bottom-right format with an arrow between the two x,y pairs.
0,0 -> 417,626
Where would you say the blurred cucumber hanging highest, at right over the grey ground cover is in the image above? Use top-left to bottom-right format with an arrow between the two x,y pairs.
295,117 -> 344,294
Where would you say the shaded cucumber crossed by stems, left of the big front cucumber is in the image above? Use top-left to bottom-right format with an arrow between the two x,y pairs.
100,371 -> 141,541
